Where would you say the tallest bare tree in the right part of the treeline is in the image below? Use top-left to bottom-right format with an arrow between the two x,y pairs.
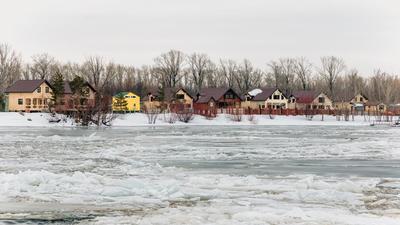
319,56 -> 346,96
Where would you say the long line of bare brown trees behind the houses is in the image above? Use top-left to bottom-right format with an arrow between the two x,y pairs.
0,44 -> 400,103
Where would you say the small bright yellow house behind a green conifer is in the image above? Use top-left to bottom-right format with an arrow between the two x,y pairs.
112,92 -> 140,112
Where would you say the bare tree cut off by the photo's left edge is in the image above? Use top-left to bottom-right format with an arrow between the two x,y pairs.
0,44 -> 21,93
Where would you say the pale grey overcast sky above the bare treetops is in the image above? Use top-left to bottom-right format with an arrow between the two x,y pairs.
0,0 -> 400,75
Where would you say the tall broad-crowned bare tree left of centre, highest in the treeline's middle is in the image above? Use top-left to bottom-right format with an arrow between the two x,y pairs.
153,50 -> 184,88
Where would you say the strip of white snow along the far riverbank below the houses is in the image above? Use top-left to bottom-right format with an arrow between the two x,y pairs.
0,112 -> 373,127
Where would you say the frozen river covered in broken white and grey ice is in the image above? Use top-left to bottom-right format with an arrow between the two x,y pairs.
0,126 -> 400,225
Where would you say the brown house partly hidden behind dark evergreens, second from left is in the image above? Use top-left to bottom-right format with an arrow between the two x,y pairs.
55,81 -> 96,112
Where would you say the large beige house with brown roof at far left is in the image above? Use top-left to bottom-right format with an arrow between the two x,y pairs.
5,80 -> 52,112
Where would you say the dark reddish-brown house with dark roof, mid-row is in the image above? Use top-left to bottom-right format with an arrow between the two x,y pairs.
193,88 -> 242,114
